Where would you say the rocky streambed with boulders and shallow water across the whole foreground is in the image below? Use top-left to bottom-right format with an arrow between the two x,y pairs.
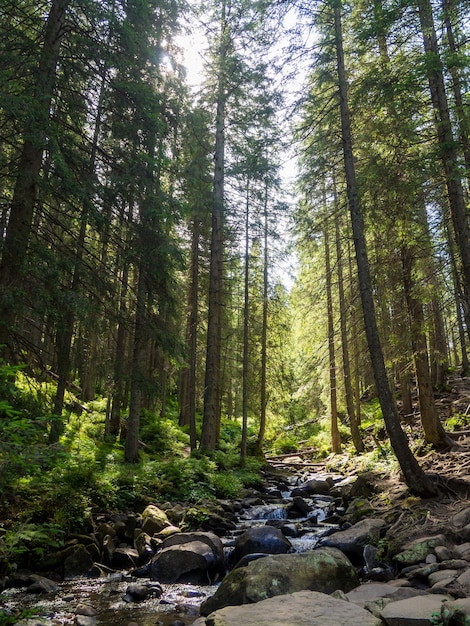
4,466 -> 470,626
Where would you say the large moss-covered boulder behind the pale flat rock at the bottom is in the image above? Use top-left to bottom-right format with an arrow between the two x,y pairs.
201,548 -> 359,615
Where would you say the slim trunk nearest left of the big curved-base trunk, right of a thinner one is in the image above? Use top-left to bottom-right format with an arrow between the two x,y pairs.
333,182 -> 364,453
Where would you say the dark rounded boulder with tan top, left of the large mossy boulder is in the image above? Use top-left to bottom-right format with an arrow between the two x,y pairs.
149,532 -> 225,584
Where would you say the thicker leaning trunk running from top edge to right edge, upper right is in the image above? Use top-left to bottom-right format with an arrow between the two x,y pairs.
417,0 -> 470,338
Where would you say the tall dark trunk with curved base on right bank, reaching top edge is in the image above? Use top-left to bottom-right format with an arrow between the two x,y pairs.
333,0 -> 437,497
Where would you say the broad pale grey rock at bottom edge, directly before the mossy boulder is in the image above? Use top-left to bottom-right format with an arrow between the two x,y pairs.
196,591 -> 382,626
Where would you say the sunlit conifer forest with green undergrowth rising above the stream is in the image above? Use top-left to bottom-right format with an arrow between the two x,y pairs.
0,0 -> 470,540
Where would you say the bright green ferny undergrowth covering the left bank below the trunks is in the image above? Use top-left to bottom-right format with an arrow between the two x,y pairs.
0,366 -> 263,536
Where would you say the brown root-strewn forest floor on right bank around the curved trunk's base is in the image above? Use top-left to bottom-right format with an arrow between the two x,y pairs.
270,375 -> 470,539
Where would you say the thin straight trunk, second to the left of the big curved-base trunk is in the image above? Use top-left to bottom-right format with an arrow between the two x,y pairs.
323,212 -> 341,453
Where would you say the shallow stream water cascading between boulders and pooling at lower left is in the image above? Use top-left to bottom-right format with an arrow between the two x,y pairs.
0,474 -> 343,626
